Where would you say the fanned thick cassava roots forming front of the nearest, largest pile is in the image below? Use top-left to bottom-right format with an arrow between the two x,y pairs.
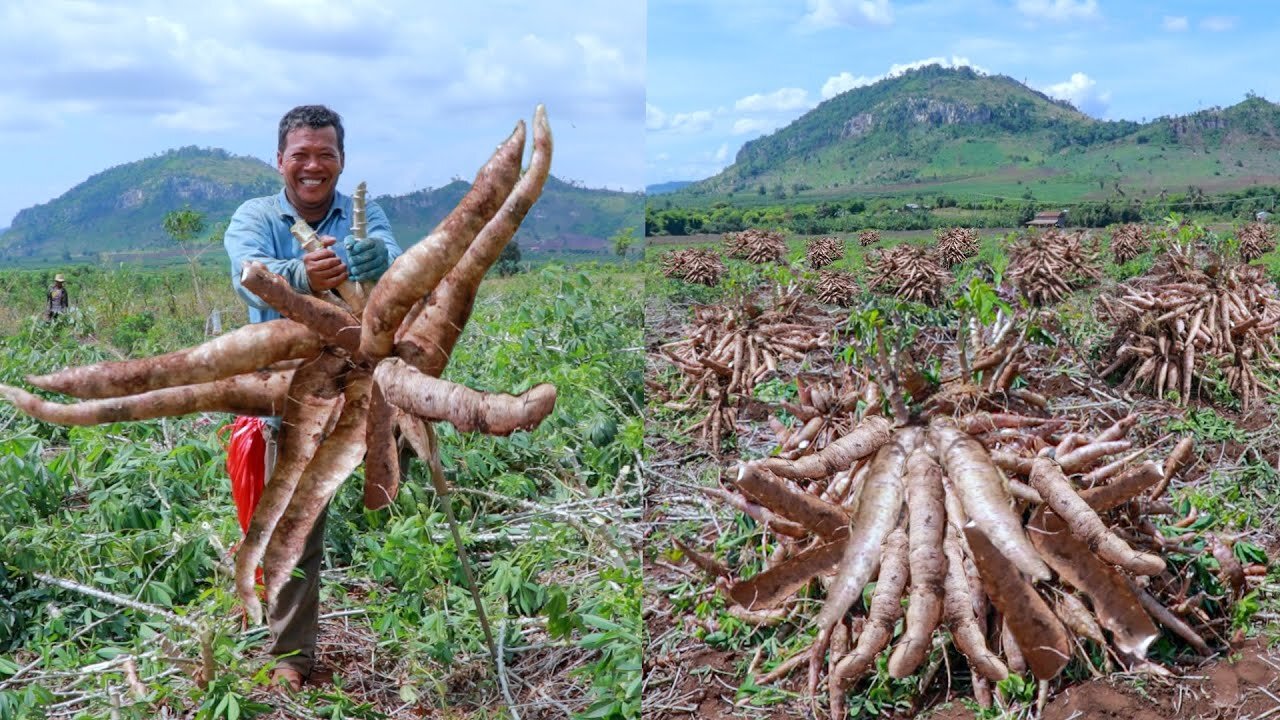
690,413 -> 1207,717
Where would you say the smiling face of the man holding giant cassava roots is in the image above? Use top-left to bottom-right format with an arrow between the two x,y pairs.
275,126 -> 342,220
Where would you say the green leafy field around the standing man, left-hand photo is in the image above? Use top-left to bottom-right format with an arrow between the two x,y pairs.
0,258 -> 643,720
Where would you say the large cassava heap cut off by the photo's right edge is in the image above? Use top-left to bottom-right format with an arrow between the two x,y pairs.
1098,242 -> 1280,410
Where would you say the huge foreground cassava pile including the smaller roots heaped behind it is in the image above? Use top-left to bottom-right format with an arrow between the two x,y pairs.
678,295 -> 1261,717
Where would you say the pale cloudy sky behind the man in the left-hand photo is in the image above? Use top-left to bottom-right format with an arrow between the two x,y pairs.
0,0 -> 646,227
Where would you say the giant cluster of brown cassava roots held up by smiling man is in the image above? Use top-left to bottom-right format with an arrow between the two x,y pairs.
0,105 -> 556,638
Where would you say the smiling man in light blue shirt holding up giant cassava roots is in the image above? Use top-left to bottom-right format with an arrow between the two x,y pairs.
224,105 -> 401,691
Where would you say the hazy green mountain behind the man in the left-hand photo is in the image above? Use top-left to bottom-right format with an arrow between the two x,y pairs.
0,146 -> 644,263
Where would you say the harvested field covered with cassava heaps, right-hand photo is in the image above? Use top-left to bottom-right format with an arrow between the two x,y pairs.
644,218 -> 1280,720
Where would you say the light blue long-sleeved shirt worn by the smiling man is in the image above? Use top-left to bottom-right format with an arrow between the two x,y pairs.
223,188 -> 401,323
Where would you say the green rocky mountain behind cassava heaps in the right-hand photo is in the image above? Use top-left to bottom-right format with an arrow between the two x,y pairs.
667,65 -> 1280,205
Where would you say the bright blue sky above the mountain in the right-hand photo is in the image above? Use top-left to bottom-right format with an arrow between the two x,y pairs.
645,0 -> 1280,184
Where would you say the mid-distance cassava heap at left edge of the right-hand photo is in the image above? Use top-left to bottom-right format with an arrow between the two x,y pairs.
658,286 -> 831,452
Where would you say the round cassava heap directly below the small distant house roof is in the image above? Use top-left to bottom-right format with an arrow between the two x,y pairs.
1007,228 -> 1102,305
